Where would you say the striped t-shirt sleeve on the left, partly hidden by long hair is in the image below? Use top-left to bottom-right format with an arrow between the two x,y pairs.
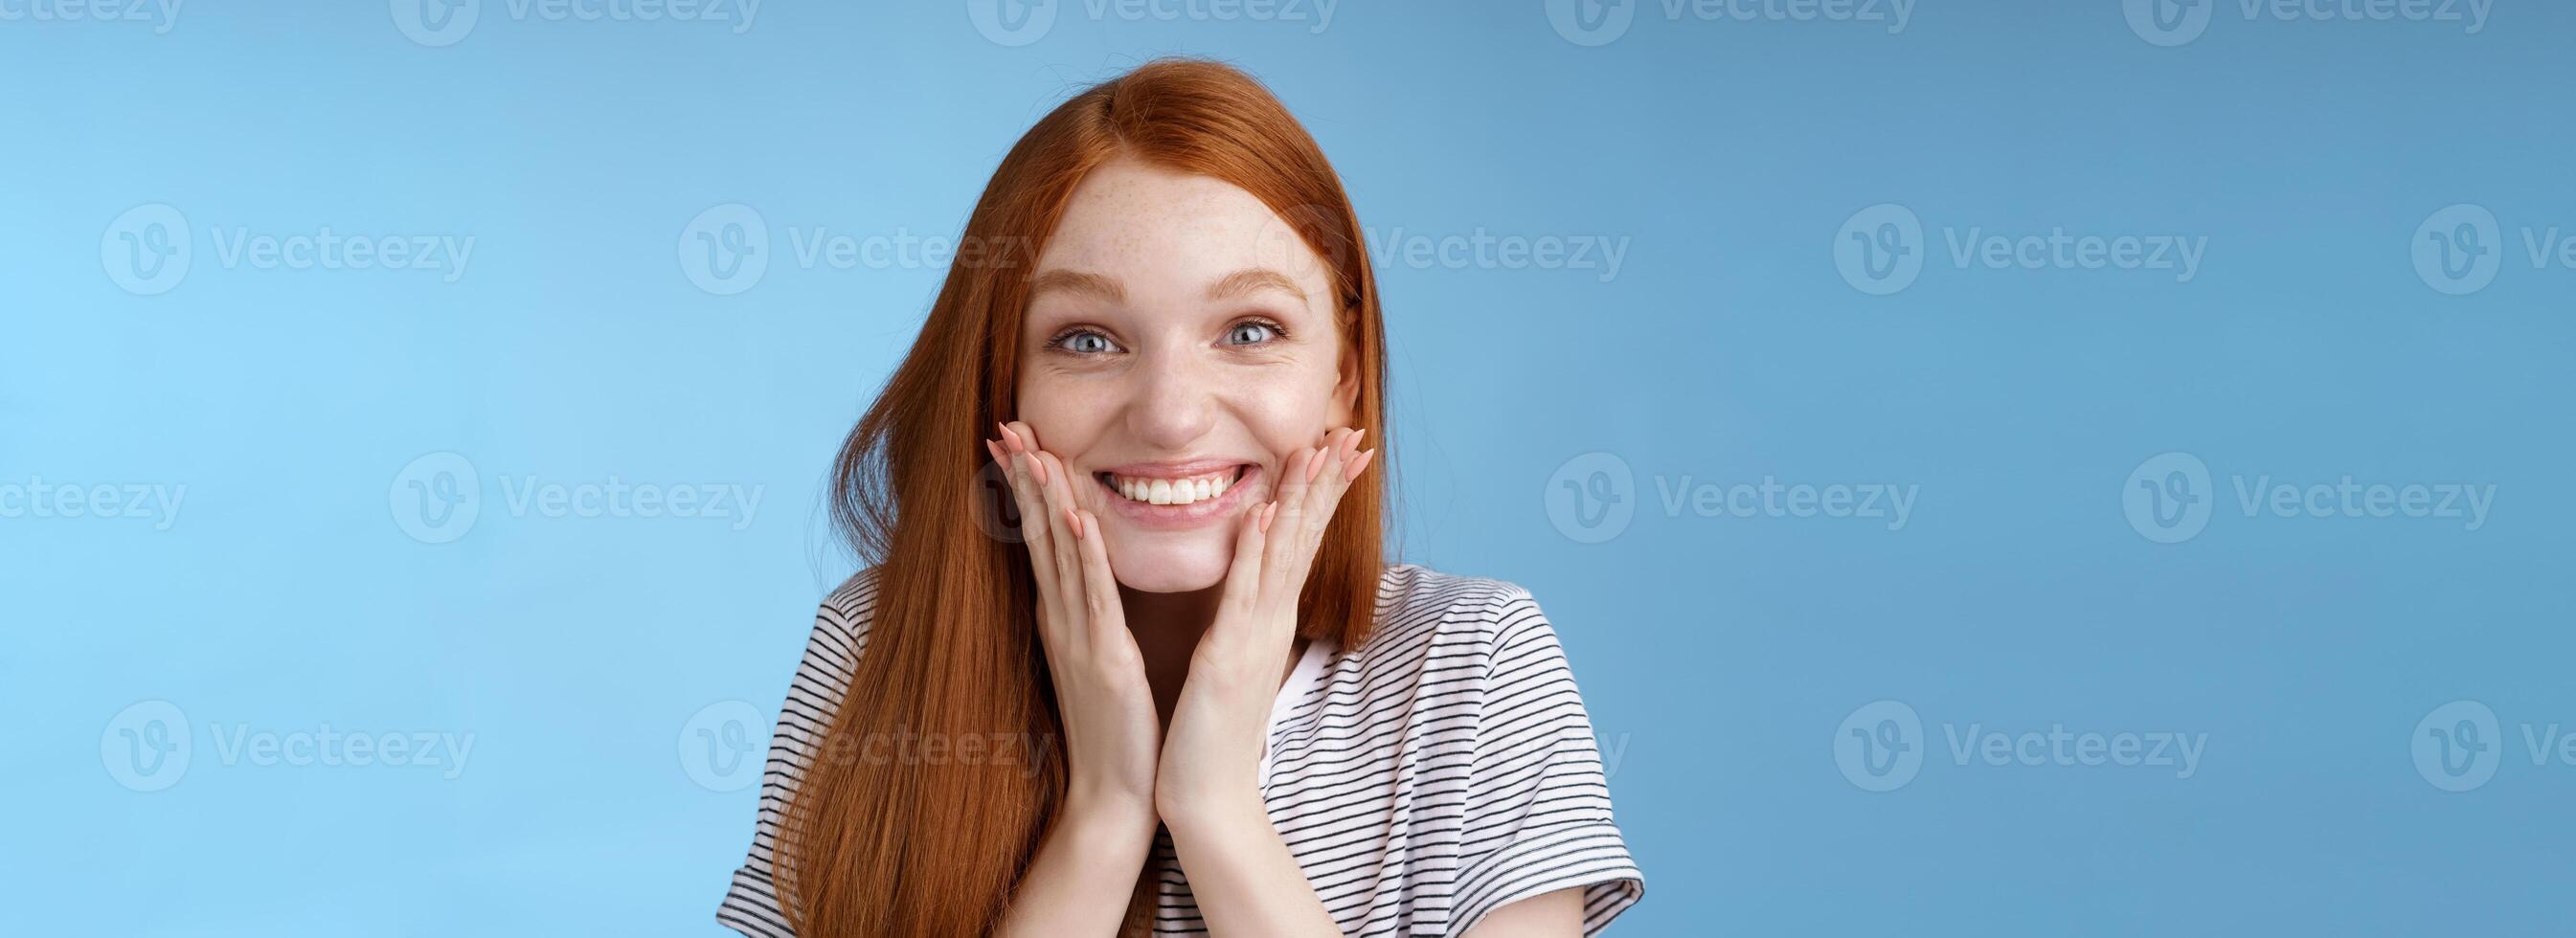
716,572 -> 876,938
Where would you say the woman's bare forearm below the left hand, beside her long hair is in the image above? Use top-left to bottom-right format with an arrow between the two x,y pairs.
1000,799 -> 1154,938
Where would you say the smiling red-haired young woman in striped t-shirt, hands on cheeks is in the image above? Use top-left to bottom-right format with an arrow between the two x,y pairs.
716,59 -> 1643,938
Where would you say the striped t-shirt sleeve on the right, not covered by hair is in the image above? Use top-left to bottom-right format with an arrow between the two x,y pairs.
1445,588 -> 1646,935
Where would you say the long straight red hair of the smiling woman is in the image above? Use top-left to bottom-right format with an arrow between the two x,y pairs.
773,59 -> 1391,938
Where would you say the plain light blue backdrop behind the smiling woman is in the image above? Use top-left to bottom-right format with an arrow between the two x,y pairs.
0,0 -> 2576,935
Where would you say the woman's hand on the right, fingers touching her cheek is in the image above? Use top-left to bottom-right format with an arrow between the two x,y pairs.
1154,428 -> 1378,825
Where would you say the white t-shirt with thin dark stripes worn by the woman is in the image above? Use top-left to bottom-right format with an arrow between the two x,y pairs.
716,565 -> 1646,938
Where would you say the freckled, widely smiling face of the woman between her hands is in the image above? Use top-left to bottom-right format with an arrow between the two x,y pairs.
1018,160 -> 1358,592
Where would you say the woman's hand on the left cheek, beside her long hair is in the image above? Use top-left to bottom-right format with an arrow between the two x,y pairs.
984,420 -> 1162,827
